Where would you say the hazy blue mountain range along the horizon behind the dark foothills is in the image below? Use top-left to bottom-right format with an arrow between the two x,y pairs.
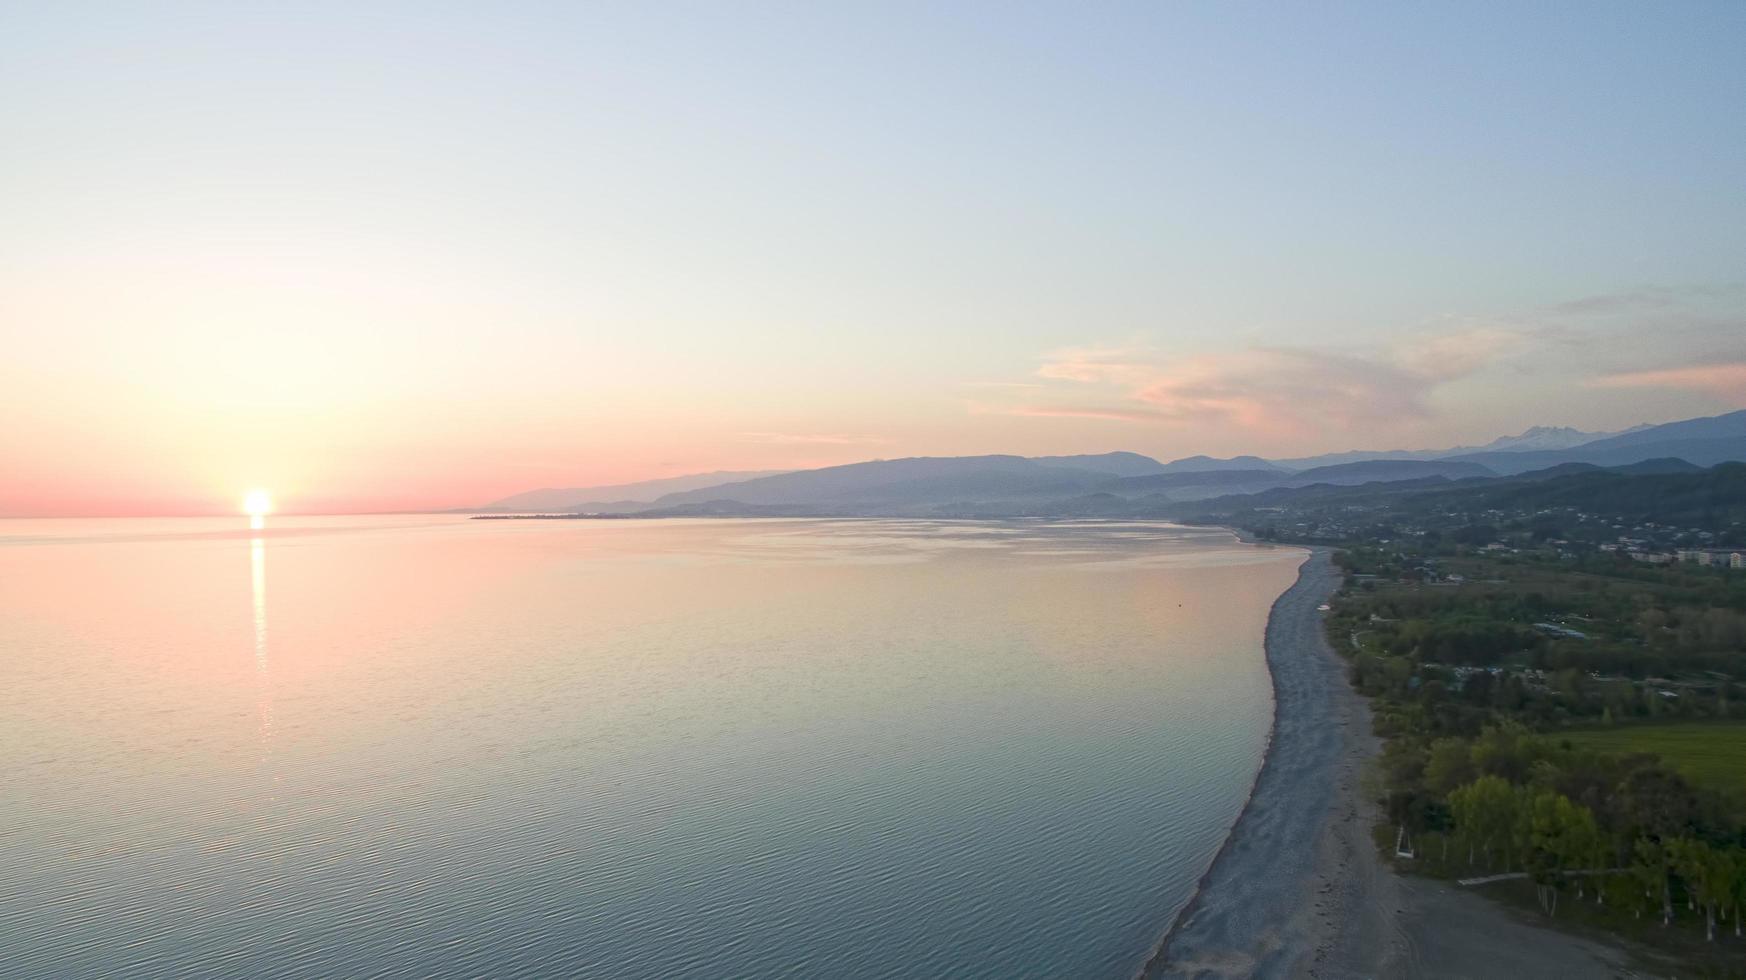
480,411 -> 1746,517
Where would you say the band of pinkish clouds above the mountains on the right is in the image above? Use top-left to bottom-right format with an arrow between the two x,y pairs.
971,283 -> 1746,445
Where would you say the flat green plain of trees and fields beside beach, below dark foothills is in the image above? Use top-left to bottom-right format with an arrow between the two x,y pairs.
1327,552 -> 1746,956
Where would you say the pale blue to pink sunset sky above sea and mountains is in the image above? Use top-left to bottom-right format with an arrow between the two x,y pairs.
0,0 -> 1746,515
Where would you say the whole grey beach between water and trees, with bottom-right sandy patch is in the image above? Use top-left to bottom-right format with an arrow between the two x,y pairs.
1142,549 -> 1639,978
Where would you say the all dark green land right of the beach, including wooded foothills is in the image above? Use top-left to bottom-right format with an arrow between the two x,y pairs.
1222,466 -> 1746,975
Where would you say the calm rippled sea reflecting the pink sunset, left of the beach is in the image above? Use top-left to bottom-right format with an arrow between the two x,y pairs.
0,517 -> 1297,978
